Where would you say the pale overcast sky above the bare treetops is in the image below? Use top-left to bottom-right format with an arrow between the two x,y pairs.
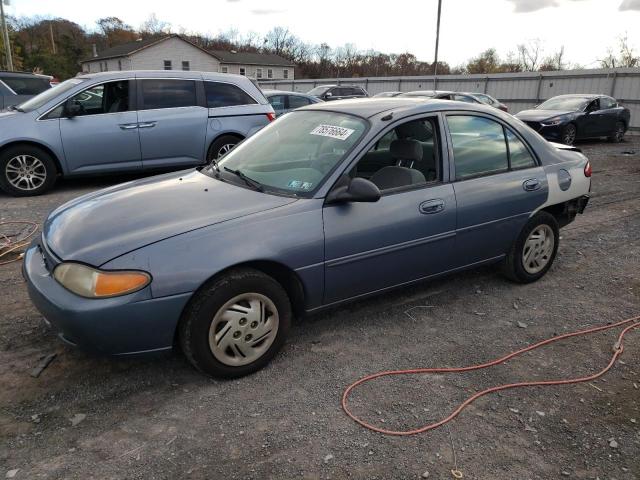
5,0 -> 640,68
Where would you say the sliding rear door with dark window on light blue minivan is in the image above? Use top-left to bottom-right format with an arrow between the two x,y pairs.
137,78 -> 207,168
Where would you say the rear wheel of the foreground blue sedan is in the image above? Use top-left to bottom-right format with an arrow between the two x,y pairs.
503,212 -> 560,283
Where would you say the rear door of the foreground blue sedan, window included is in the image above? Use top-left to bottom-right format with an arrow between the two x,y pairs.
447,113 -> 548,266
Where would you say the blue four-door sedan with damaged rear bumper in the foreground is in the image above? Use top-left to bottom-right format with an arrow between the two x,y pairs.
24,98 -> 591,377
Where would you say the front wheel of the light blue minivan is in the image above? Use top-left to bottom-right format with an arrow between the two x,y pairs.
0,145 -> 58,197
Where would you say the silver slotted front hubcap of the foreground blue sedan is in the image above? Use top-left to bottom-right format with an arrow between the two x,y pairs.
209,293 -> 279,367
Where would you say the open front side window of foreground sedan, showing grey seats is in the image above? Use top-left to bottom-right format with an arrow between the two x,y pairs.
350,118 -> 440,190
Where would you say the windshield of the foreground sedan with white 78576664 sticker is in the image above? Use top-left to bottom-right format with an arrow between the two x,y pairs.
212,110 -> 368,197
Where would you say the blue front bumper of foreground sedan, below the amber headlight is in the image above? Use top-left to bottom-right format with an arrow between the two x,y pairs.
23,239 -> 191,355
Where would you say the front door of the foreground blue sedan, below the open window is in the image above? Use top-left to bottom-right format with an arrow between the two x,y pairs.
323,117 -> 456,303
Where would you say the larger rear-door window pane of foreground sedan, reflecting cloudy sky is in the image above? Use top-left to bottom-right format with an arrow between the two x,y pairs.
447,115 -> 509,180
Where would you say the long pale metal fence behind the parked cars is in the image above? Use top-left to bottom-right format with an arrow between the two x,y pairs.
260,68 -> 640,132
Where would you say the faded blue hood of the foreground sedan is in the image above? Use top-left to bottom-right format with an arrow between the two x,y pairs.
43,170 -> 296,266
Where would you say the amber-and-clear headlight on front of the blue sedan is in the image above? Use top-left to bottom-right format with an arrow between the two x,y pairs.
53,260 -> 151,298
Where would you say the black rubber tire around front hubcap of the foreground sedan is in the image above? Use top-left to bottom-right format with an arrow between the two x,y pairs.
178,268 -> 292,378
